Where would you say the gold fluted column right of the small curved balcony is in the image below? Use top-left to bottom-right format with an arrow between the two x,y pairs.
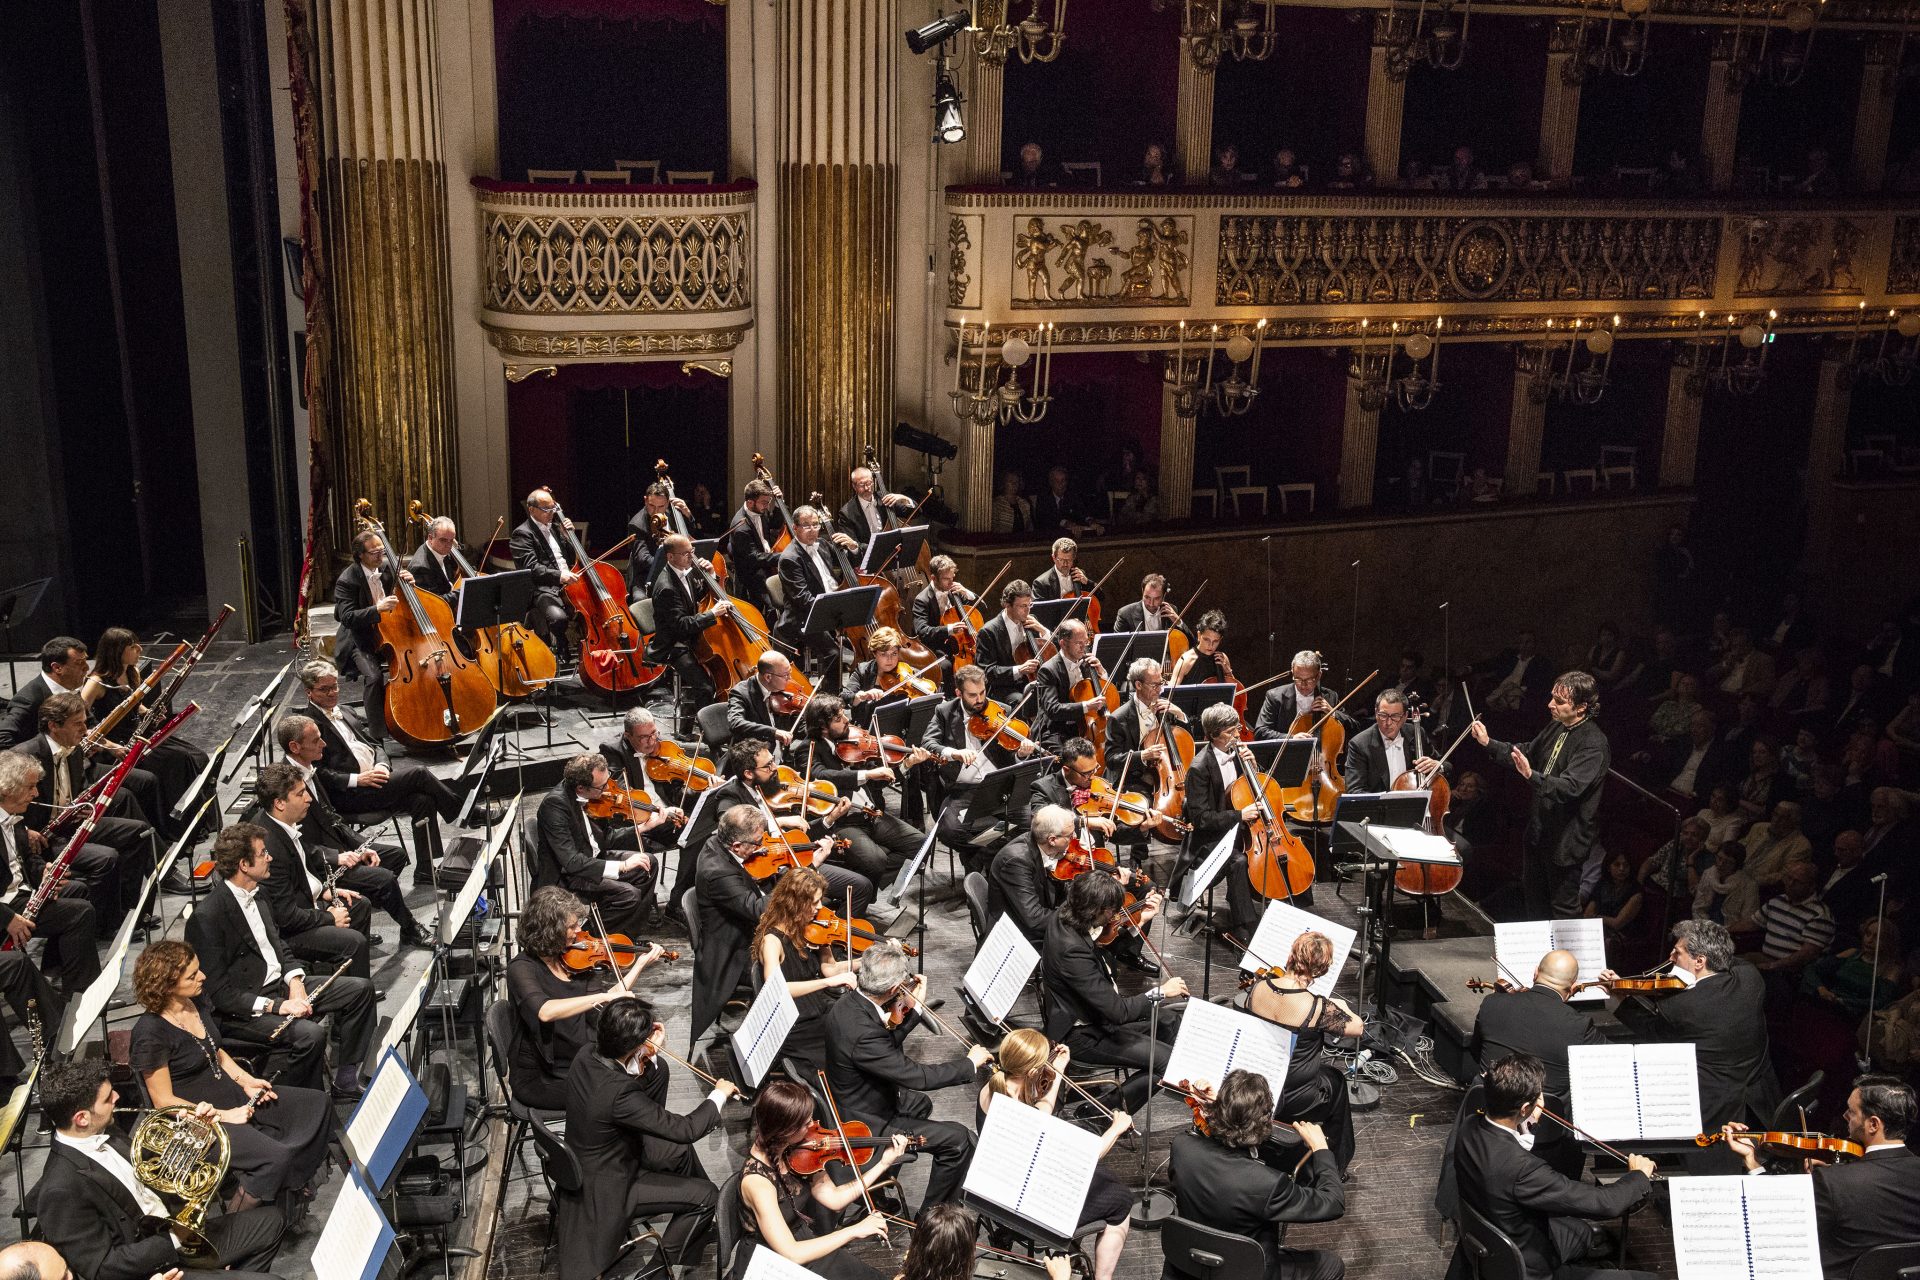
778,0 -> 900,505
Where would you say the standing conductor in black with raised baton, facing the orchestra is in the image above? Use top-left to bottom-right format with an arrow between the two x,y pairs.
1471,672 -> 1611,919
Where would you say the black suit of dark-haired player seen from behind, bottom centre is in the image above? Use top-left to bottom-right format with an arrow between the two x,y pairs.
1162,1130 -> 1346,1280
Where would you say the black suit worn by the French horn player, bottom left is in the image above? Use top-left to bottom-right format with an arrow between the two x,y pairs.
33,1130 -> 286,1280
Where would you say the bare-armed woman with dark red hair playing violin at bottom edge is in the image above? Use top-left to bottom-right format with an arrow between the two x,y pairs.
720,1080 -> 908,1280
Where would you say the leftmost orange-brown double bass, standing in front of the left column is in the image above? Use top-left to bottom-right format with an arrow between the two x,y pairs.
353,497 -> 495,748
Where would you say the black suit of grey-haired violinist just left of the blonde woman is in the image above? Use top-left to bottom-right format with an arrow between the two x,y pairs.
828,992 -> 973,1205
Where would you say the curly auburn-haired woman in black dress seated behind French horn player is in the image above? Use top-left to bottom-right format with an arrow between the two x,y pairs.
132,942 -> 332,1219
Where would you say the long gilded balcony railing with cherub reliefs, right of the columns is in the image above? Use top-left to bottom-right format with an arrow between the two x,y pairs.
945,188 -> 1920,349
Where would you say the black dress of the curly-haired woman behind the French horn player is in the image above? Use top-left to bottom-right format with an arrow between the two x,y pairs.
131,996 -> 334,1201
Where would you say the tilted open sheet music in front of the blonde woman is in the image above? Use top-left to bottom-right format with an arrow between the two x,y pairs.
966,1094 -> 1100,1238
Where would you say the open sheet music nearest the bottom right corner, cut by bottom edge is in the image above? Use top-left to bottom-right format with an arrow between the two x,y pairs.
1667,1174 -> 1822,1280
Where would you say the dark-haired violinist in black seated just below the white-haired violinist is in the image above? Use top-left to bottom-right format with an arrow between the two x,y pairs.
1041,875 -> 1187,1111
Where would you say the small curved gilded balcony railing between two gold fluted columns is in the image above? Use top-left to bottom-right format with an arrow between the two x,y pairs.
474,178 -> 756,361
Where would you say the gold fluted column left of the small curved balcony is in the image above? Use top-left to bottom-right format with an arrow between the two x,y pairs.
307,0 -> 459,551
